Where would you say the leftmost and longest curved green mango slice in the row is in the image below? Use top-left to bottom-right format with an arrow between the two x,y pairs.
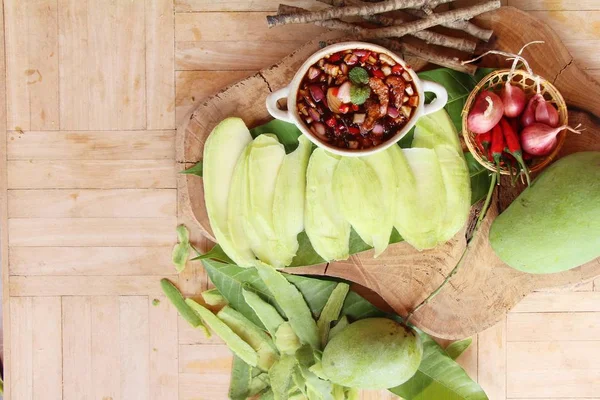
203,118 -> 254,265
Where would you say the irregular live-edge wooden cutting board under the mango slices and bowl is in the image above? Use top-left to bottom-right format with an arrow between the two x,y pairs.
176,7 -> 600,339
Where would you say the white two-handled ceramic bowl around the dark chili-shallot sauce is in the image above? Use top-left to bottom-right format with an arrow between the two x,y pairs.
267,42 -> 448,156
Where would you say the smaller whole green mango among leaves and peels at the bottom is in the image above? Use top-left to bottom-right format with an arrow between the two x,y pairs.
322,318 -> 423,389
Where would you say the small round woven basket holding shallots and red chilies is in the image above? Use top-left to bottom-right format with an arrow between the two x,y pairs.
462,69 -> 568,175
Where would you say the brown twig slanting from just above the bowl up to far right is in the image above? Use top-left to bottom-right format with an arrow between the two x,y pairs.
359,0 -> 501,39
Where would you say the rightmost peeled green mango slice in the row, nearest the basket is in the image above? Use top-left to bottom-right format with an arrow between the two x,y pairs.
434,144 -> 471,243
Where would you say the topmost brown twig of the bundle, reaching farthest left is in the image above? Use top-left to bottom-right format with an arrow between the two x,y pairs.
267,0 -> 454,28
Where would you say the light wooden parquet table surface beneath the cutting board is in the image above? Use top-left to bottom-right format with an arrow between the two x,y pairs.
0,0 -> 600,400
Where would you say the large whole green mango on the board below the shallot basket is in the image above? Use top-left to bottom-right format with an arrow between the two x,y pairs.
490,152 -> 600,274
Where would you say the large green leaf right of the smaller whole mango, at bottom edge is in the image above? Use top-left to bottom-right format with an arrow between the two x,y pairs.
390,331 -> 488,400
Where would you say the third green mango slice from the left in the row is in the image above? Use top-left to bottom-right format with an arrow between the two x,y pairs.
243,134 -> 285,268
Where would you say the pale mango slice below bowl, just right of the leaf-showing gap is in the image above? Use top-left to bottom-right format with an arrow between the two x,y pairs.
304,149 -> 350,261
